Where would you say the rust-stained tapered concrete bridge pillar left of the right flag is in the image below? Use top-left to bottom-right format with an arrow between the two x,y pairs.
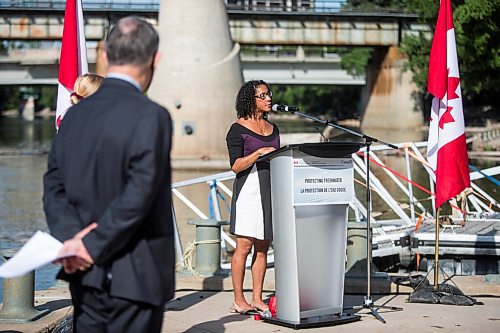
361,46 -> 423,142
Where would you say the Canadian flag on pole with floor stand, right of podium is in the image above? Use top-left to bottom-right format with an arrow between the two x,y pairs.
408,0 -> 475,305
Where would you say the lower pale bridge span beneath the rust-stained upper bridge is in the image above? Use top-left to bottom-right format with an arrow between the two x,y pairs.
0,47 -> 366,86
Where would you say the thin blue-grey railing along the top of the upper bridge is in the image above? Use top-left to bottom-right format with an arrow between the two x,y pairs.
0,0 -> 402,13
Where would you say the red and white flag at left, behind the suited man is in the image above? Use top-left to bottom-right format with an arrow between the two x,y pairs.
56,0 -> 89,129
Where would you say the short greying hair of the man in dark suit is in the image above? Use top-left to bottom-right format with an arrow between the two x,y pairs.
106,16 -> 160,66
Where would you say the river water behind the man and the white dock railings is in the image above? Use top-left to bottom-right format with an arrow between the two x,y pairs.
0,117 -> 500,302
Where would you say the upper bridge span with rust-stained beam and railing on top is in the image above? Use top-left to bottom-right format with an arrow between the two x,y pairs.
0,0 -> 428,46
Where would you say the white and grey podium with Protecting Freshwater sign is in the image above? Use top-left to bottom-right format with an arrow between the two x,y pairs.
261,142 -> 363,329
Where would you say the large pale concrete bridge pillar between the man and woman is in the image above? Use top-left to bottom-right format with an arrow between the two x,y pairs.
148,0 -> 243,160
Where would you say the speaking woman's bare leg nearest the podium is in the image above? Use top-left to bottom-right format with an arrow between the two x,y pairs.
251,239 -> 270,310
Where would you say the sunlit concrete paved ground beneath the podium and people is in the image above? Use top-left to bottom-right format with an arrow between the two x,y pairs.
0,269 -> 500,333
